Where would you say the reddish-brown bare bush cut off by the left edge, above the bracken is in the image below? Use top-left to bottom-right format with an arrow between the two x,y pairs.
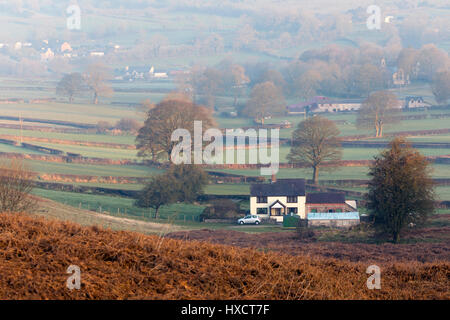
0,160 -> 36,213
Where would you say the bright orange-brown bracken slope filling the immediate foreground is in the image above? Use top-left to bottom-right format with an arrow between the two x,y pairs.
0,214 -> 450,299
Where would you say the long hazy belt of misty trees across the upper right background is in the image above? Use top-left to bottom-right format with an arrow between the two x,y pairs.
177,44 -> 450,120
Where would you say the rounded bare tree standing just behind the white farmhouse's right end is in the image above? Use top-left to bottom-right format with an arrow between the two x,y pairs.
288,116 -> 342,184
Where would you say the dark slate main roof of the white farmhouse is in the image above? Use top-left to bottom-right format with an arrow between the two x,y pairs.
250,179 -> 305,197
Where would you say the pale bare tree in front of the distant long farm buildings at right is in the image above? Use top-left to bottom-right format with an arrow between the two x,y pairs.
356,91 -> 399,138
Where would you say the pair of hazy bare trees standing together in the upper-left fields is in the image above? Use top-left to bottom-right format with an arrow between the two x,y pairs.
56,63 -> 114,104
